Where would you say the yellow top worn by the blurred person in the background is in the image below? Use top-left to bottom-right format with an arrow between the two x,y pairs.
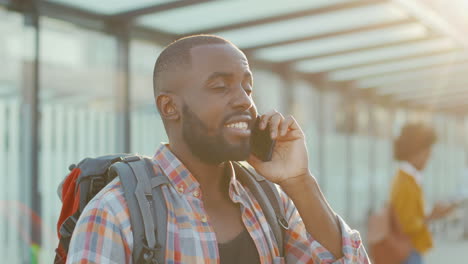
390,169 -> 432,253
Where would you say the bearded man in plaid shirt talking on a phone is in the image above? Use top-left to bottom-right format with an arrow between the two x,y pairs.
68,35 -> 368,263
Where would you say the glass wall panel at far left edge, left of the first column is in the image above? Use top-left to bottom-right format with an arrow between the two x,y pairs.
0,7 -> 34,263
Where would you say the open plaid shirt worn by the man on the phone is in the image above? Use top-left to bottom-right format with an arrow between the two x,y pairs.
67,145 -> 369,264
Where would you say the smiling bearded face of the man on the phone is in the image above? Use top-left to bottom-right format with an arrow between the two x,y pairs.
181,44 -> 257,164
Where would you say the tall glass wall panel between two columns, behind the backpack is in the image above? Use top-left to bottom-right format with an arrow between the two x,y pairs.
39,17 -> 122,263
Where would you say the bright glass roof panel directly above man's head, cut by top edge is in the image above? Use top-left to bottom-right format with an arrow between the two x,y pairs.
137,0 -> 355,34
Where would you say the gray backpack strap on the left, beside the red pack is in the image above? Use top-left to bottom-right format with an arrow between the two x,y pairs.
111,156 -> 169,263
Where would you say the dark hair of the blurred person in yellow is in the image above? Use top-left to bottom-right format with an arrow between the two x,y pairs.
393,123 -> 437,161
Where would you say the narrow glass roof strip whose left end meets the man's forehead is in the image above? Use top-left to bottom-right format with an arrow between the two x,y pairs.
254,23 -> 427,62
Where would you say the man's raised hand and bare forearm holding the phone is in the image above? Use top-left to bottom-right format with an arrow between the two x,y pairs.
248,111 -> 343,259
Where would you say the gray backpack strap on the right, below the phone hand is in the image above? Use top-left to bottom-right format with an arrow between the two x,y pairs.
233,162 -> 289,257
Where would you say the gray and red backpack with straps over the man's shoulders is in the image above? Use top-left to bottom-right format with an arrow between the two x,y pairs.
54,154 -> 288,264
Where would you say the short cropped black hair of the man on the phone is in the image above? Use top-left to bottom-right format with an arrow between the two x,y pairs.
153,35 -> 237,98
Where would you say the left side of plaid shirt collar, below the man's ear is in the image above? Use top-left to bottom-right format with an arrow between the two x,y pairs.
153,143 -> 200,194
